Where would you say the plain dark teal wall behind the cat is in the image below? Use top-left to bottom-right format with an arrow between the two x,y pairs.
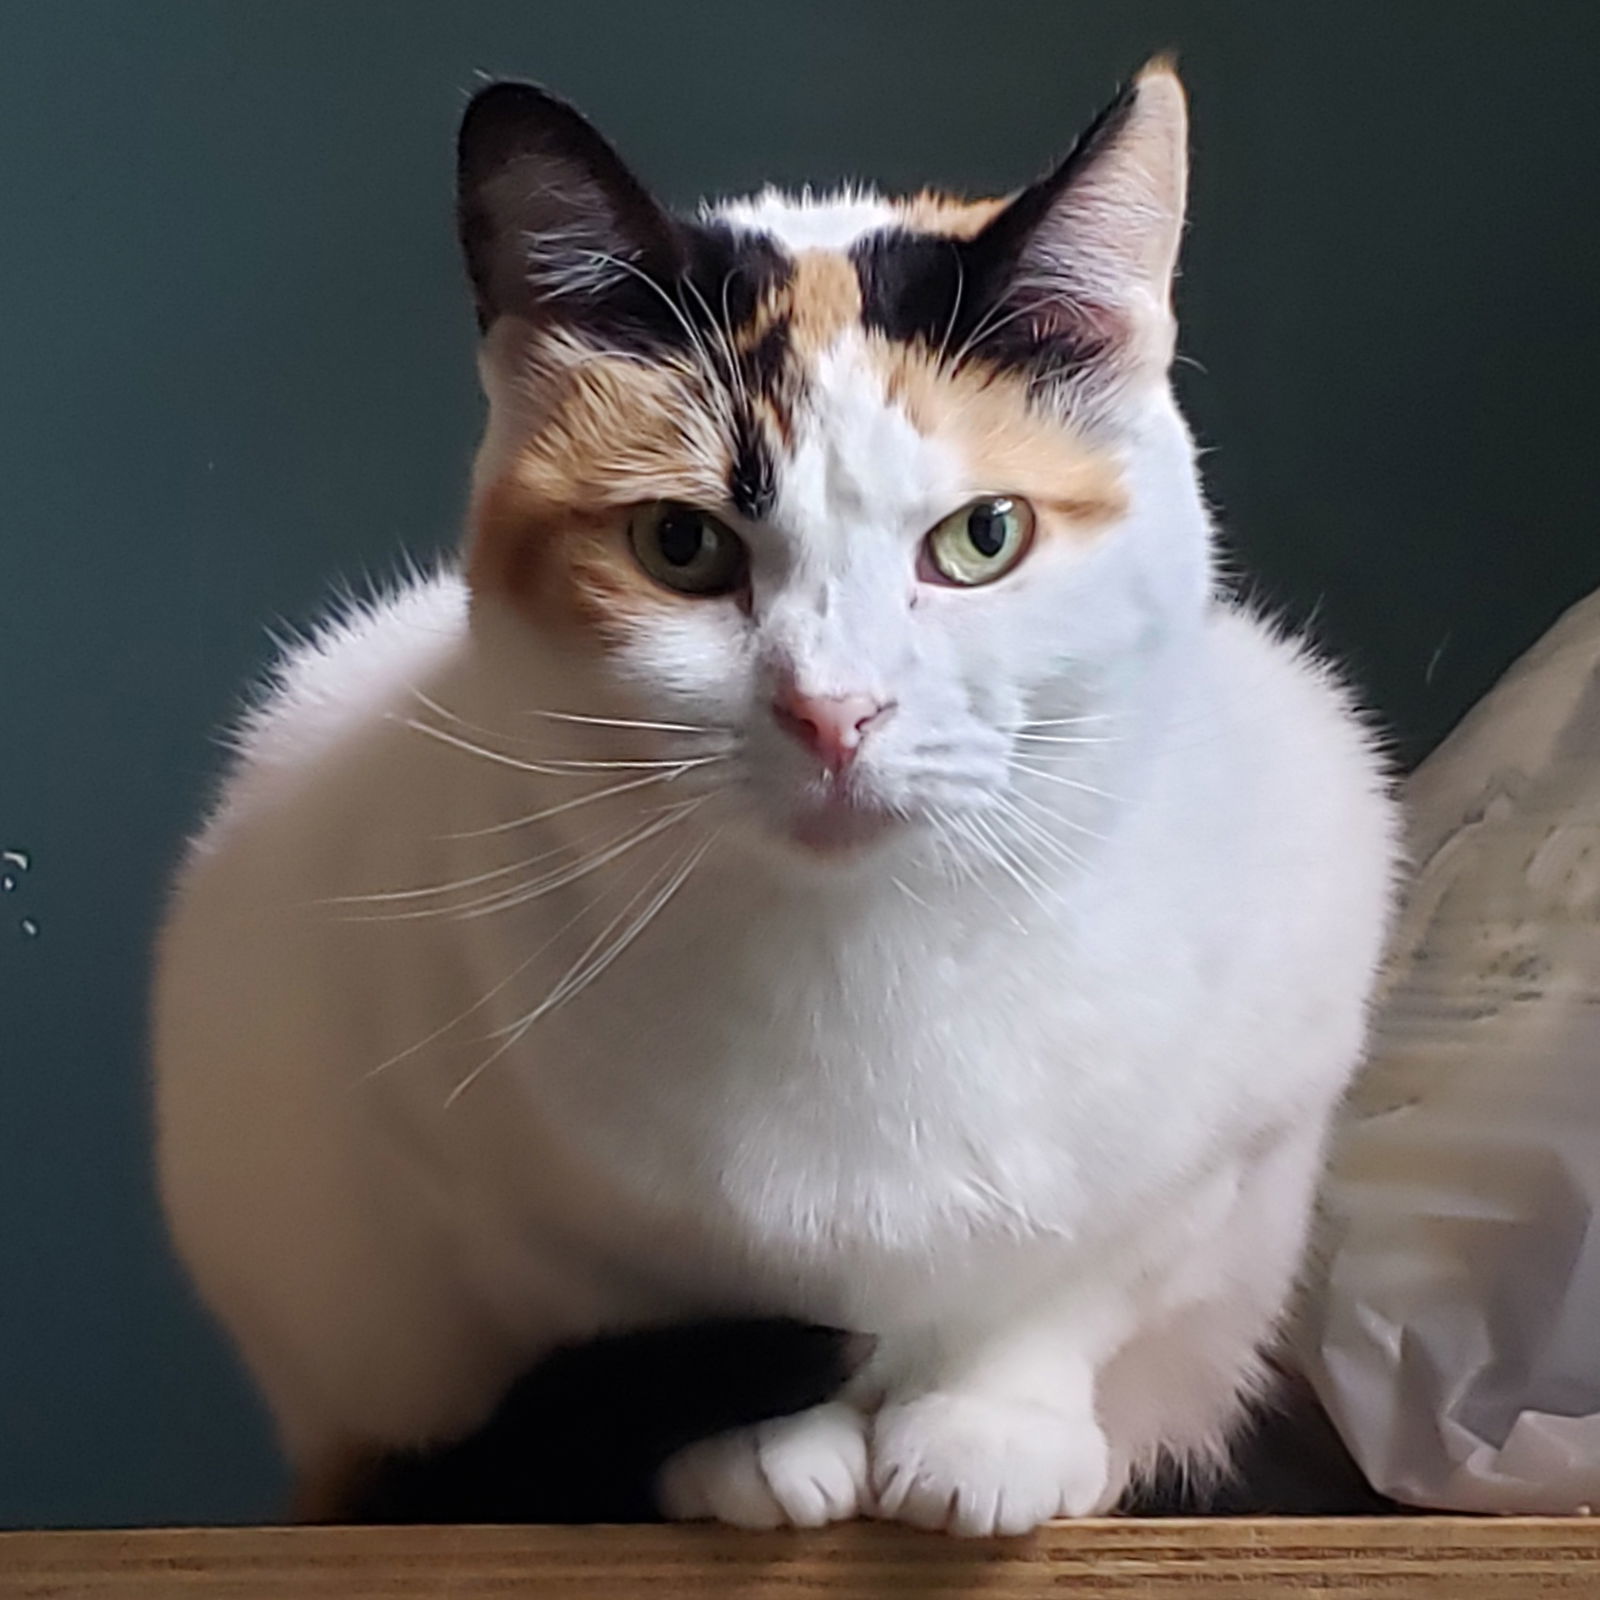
0,0 -> 1600,1525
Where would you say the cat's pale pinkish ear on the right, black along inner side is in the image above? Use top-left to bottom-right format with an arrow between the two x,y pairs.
974,58 -> 1189,390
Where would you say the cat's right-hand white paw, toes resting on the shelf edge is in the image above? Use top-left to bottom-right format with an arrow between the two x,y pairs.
870,1394 -> 1115,1538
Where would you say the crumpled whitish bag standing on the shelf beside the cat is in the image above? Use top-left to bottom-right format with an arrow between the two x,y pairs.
1301,594 -> 1600,1514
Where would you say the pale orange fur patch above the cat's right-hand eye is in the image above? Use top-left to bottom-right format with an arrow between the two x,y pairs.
870,339 -> 1128,539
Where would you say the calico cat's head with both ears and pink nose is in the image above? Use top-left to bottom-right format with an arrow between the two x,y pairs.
459,62 -> 1208,848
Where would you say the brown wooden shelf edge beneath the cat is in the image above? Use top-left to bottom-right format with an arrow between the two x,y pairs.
0,1517 -> 1600,1600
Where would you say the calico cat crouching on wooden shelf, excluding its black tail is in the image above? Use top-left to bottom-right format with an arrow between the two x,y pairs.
154,61 -> 1395,1536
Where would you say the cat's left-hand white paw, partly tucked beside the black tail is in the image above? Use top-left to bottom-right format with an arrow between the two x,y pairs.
656,1400 -> 867,1528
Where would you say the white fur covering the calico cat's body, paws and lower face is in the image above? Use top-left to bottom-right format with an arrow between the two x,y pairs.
155,190 -> 1390,1533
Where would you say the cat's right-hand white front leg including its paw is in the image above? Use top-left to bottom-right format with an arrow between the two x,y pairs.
869,1314 -> 1126,1538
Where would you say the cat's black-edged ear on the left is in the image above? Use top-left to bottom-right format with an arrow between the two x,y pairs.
456,82 -> 680,330
